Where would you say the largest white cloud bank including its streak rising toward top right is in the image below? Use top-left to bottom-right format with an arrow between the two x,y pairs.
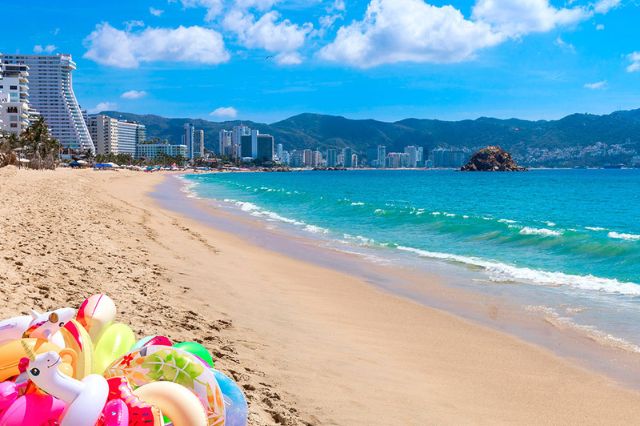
319,0 -> 621,68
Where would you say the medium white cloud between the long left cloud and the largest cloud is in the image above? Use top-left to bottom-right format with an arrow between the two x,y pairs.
223,9 -> 313,55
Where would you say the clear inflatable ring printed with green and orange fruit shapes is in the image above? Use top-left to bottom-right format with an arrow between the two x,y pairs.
104,345 -> 225,426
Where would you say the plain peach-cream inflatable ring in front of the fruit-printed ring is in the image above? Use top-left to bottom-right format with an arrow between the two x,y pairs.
133,382 -> 208,426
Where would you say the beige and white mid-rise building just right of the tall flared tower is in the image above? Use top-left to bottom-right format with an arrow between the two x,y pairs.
87,114 -> 146,157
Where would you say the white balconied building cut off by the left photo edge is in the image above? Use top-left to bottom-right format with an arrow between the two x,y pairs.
0,63 -> 31,135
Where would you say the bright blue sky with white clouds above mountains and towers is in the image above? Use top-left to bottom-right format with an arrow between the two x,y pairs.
0,0 -> 640,123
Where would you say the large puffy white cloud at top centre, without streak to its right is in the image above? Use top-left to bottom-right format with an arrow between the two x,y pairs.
320,0 -> 503,68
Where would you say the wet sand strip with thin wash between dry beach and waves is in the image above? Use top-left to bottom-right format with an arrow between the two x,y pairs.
170,174 -> 640,390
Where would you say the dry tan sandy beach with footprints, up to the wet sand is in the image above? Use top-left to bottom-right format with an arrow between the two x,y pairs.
0,168 -> 640,425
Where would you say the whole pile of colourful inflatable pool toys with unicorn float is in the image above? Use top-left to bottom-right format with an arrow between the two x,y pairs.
0,294 -> 248,426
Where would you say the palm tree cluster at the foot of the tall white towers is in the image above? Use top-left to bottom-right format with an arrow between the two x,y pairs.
0,117 -> 60,170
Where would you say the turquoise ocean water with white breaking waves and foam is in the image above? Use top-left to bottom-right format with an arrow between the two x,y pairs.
185,170 -> 640,352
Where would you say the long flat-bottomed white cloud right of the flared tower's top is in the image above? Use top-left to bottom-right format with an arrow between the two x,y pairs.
84,23 -> 229,68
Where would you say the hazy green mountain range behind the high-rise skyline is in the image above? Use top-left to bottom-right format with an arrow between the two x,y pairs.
103,109 -> 640,167
